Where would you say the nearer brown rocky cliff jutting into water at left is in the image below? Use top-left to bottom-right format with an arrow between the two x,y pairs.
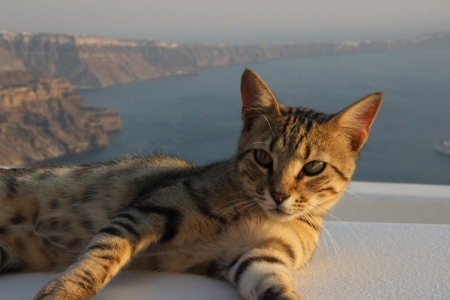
0,71 -> 121,165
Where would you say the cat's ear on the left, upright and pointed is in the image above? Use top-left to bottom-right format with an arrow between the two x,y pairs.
241,69 -> 280,128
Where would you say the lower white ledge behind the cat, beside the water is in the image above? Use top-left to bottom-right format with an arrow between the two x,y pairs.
326,182 -> 450,224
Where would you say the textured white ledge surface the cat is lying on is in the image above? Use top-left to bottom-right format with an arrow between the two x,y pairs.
0,222 -> 450,300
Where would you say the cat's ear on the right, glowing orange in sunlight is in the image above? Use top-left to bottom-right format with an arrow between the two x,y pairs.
335,93 -> 383,151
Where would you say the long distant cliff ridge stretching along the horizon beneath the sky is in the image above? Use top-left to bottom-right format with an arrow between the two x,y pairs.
0,32 -> 450,87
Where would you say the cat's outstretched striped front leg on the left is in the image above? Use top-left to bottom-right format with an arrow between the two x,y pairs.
34,204 -> 182,300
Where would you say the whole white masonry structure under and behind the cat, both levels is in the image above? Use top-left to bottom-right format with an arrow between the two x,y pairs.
0,182 -> 450,300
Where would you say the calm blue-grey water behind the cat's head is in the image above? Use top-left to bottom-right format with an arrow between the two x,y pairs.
41,49 -> 450,184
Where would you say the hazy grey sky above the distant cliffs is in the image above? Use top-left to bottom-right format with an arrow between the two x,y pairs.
0,0 -> 450,44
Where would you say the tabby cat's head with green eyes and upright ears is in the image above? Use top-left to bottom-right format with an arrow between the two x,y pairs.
237,70 -> 382,221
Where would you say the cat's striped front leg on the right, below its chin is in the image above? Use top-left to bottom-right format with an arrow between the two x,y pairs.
227,249 -> 300,300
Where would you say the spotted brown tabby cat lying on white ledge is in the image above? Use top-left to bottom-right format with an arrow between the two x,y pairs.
0,69 -> 382,300
